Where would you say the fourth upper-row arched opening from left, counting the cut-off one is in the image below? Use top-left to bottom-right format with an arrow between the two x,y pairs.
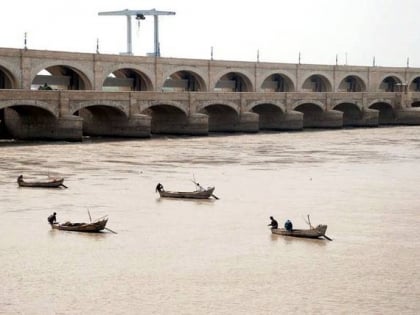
162,71 -> 206,92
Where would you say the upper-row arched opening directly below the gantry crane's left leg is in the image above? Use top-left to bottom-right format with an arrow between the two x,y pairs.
102,68 -> 153,92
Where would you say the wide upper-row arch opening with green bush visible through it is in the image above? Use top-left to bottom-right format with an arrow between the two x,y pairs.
31,64 -> 93,90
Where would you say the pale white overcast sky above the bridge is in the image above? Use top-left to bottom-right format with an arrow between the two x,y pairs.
0,0 -> 420,67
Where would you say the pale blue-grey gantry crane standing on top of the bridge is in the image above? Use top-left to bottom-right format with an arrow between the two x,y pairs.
98,9 -> 175,57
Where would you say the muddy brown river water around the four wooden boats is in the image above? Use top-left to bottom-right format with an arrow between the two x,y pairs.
0,127 -> 420,314
